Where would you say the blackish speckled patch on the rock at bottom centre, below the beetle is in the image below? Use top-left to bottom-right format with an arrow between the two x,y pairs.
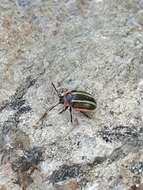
49,164 -> 82,184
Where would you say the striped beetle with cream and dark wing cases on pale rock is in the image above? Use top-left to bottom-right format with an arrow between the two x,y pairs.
48,83 -> 96,122
